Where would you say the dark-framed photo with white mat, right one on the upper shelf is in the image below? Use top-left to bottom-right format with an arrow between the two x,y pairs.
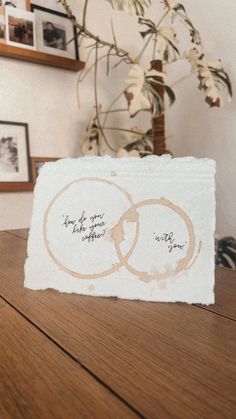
31,4 -> 79,60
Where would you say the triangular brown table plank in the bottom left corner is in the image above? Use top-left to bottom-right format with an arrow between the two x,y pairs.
0,299 -> 137,419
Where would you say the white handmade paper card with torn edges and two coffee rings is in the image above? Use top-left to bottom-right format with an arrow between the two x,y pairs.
25,156 -> 215,304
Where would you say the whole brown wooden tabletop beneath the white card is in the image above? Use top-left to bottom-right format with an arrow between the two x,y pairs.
0,230 -> 236,419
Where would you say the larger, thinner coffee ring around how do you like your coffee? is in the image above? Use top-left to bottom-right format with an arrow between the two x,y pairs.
43,177 -> 139,279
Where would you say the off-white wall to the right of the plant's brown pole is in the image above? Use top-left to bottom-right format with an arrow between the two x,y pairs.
167,0 -> 236,237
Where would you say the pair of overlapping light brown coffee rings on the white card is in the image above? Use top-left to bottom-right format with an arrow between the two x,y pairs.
43,177 -> 195,281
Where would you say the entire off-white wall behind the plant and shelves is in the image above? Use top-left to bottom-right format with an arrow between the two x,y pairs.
0,0 -> 236,236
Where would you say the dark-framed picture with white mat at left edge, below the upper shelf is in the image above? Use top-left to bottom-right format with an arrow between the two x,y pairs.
0,121 -> 32,190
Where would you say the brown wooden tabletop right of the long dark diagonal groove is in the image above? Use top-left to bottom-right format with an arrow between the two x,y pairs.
0,232 -> 236,419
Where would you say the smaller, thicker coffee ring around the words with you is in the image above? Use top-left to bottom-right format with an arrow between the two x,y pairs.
114,198 -> 195,281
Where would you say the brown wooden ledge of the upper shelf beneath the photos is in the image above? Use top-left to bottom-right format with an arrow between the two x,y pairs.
0,43 -> 84,71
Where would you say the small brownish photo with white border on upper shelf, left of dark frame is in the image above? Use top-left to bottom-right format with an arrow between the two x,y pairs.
5,6 -> 36,50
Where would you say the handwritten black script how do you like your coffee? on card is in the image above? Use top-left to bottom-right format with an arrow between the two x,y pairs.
62,210 -> 106,243
